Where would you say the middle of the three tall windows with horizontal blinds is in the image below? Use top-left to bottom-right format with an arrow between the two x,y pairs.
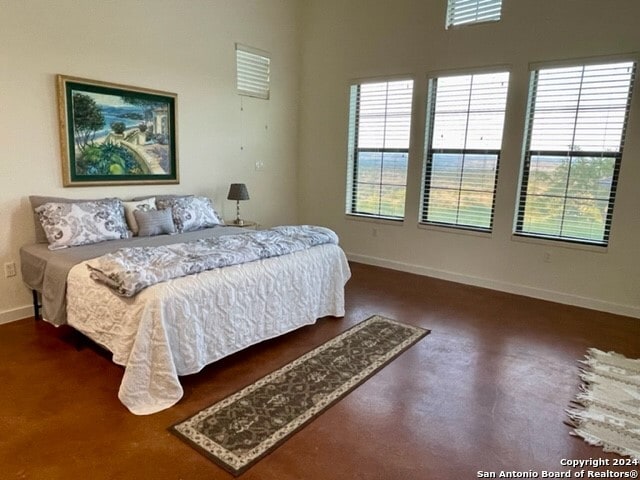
420,72 -> 509,231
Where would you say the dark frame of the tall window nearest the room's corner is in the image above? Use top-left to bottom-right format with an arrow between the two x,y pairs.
345,76 -> 416,224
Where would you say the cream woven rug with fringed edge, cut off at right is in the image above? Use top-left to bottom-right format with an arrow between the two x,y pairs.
567,348 -> 640,459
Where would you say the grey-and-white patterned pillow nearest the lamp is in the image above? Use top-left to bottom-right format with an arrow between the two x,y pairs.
156,197 -> 224,232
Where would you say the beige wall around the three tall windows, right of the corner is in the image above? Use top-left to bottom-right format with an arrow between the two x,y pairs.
299,0 -> 640,317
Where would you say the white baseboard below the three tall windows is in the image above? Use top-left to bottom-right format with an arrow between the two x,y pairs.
347,253 -> 640,318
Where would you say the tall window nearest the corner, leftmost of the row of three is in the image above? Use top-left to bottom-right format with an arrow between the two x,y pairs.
346,80 -> 413,220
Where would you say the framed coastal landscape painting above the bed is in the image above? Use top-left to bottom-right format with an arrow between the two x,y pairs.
56,75 -> 179,187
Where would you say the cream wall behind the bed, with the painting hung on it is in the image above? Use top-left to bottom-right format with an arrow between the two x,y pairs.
0,0 -> 299,323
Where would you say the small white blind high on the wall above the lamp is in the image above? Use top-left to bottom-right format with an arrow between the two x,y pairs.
236,44 -> 271,100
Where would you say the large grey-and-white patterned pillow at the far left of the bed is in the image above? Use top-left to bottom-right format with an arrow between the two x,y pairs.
35,199 -> 130,250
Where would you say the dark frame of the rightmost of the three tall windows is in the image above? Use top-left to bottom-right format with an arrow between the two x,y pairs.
513,55 -> 639,251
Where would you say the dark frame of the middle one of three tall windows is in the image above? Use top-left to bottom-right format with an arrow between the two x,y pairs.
418,69 -> 511,234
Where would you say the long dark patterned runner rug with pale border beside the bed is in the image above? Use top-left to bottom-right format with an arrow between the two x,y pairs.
170,315 -> 429,475
